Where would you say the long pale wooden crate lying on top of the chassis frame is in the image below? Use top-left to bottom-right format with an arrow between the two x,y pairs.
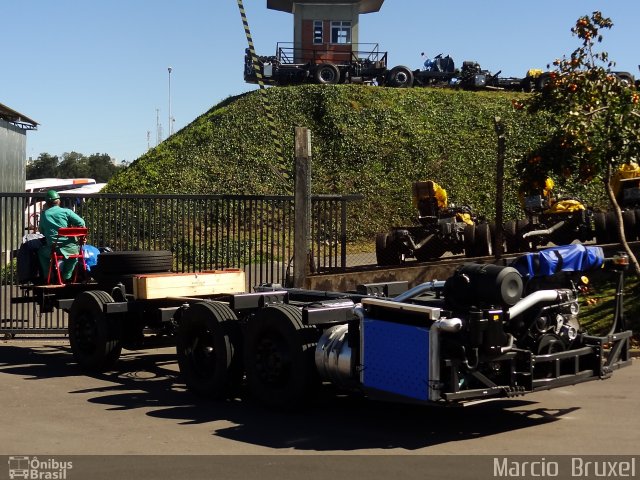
133,269 -> 245,300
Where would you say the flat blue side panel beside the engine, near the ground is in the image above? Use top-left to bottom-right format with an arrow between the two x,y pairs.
362,319 -> 429,400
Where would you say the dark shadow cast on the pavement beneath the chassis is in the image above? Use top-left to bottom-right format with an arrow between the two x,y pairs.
0,344 -> 577,453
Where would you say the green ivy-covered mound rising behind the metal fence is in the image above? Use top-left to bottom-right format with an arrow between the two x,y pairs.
104,85 -> 602,238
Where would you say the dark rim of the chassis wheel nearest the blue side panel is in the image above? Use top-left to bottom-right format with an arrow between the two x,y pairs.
255,332 -> 291,387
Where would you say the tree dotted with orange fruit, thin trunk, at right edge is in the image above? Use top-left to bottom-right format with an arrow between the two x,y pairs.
515,11 -> 640,276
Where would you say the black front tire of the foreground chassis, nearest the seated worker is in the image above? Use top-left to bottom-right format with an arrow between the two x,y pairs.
68,290 -> 122,373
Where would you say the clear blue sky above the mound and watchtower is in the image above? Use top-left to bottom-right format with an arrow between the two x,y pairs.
0,0 -> 640,162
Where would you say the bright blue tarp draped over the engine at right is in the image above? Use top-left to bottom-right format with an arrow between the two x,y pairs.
511,244 -> 604,278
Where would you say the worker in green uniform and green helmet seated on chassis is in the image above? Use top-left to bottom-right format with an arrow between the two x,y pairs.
38,190 -> 84,282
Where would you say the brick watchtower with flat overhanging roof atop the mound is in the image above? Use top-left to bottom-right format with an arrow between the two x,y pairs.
267,0 -> 384,63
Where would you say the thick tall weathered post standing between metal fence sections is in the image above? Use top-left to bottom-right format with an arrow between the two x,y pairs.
293,127 -> 311,288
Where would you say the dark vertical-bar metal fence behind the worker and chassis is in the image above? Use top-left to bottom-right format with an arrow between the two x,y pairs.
0,193 -> 358,334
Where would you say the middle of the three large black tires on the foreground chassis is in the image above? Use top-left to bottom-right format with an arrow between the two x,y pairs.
176,302 -> 243,399
